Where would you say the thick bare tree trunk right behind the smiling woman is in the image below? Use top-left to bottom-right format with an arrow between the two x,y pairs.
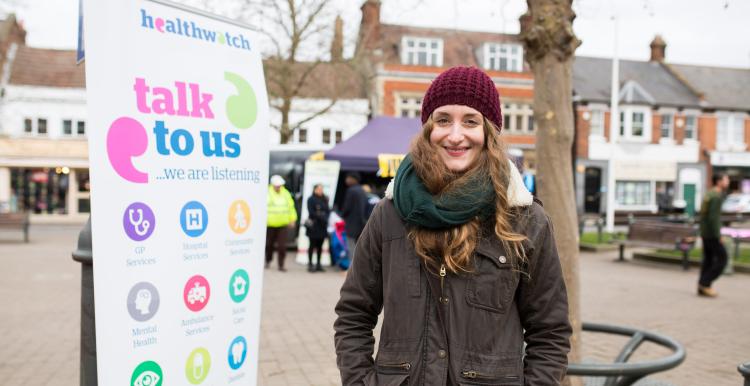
520,0 -> 581,384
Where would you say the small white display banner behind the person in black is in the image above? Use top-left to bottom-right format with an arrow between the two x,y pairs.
296,160 -> 341,265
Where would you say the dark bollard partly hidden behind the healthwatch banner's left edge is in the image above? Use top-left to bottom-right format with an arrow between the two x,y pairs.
73,216 -> 97,386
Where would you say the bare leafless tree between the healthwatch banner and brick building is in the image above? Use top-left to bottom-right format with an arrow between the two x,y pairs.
202,0 -> 351,144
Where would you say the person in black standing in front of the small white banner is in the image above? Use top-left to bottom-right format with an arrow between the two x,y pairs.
305,184 -> 331,272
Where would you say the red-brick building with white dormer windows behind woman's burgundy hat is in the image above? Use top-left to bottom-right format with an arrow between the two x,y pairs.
357,0 -> 536,171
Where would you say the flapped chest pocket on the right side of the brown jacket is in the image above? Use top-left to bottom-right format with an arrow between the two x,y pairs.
466,254 -> 518,314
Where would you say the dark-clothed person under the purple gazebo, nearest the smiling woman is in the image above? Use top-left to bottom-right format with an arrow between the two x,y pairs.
341,172 -> 367,260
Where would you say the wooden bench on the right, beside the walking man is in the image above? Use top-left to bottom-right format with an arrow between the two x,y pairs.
617,220 -> 698,270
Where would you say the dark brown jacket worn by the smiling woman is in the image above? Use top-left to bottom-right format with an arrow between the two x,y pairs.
334,164 -> 571,386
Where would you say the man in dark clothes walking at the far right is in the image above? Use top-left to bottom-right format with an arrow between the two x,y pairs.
698,174 -> 729,298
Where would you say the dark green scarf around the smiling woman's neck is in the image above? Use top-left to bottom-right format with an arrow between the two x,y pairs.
393,154 -> 495,229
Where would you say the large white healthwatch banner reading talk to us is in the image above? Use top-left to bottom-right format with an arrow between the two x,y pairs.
84,0 -> 269,386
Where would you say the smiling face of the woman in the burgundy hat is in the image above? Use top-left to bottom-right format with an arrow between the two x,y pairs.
430,105 -> 484,172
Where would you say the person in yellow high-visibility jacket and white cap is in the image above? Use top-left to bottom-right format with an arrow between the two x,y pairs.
266,174 -> 297,272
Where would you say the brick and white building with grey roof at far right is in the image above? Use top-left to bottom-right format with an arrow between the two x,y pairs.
573,36 -> 750,217
